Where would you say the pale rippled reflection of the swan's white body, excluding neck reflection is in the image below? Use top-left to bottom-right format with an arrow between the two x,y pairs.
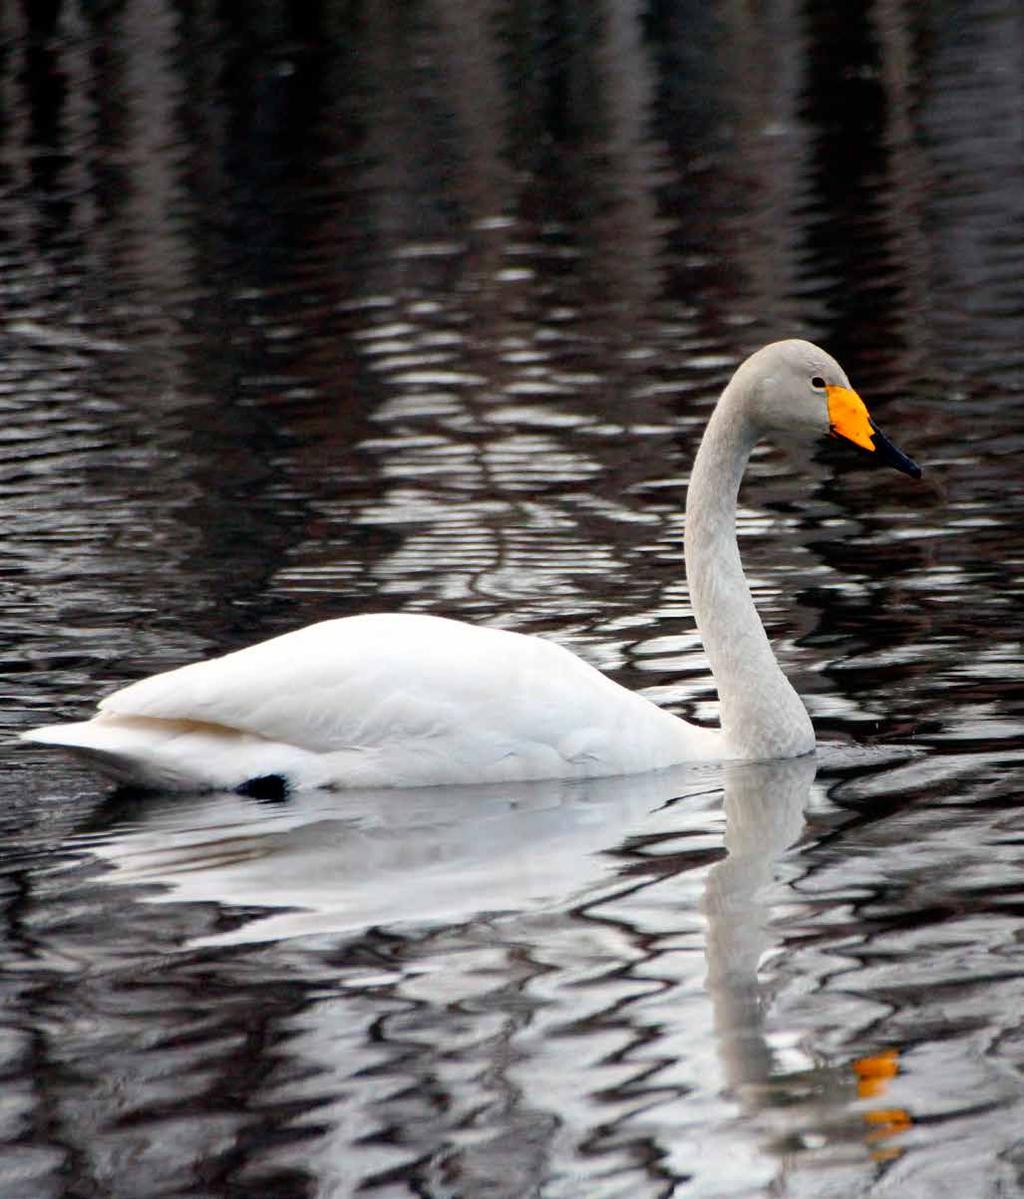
76,759 -> 729,944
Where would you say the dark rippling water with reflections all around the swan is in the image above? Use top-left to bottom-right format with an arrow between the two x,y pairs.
0,0 -> 1024,1199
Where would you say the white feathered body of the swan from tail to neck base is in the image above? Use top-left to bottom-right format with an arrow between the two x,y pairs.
34,614 -> 717,788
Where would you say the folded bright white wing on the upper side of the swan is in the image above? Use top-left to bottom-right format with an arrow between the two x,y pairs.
100,614 -> 651,753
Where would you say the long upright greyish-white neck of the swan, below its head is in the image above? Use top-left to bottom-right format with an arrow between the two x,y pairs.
686,388 -> 814,759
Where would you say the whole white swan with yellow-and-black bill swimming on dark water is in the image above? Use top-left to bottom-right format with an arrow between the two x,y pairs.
22,339 -> 921,794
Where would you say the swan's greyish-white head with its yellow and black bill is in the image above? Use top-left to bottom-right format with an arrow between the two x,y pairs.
734,339 -> 921,478
